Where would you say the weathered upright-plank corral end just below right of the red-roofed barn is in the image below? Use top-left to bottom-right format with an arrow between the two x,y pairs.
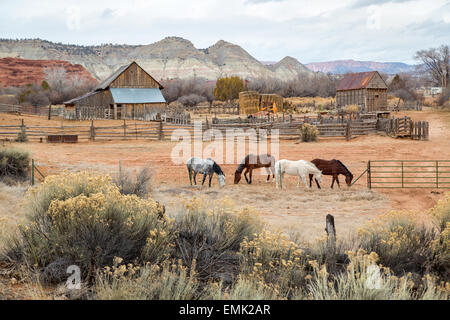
377,116 -> 430,140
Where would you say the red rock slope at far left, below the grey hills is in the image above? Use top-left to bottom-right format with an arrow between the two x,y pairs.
0,58 -> 97,87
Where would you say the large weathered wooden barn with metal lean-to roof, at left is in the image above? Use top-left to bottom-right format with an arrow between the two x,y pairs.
64,62 -> 167,120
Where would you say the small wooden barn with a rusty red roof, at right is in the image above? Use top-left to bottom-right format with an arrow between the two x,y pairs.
336,71 -> 387,113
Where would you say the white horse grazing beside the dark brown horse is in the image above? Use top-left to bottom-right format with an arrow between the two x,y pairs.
275,159 -> 322,189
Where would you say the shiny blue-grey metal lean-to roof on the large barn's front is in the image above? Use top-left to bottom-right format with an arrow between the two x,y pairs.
109,88 -> 166,103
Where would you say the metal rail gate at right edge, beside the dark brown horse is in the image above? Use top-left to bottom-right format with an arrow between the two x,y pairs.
366,160 -> 450,189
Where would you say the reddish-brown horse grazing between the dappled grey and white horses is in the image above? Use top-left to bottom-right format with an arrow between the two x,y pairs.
234,154 -> 275,184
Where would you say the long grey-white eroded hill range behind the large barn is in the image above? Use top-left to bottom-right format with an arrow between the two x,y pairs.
0,37 -> 313,80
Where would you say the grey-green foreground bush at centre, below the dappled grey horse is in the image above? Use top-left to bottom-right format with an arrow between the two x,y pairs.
174,197 -> 261,282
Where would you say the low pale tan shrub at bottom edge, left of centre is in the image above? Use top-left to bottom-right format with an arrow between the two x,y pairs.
95,262 -> 201,300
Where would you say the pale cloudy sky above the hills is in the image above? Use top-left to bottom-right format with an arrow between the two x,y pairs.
0,0 -> 450,63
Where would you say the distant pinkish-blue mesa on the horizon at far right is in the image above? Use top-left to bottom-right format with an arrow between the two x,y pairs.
306,60 -> 416,74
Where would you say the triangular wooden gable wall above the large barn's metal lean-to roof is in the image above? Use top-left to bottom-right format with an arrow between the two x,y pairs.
110,63 -> 160,88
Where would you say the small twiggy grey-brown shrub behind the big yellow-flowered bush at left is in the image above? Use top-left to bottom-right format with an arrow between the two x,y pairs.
113,163 -> 152,198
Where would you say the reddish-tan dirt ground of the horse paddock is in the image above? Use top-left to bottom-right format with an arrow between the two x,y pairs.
0,110 -> 450,239
